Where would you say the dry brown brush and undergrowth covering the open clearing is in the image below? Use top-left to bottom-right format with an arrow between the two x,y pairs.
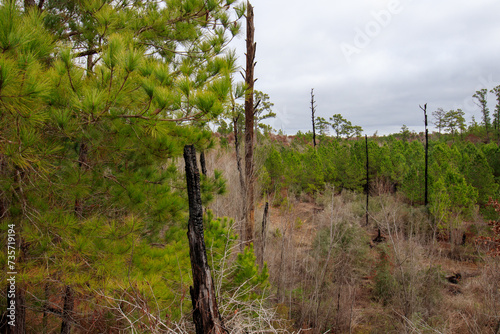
204,134 -> 500,334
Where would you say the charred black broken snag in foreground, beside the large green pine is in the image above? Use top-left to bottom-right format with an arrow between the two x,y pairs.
184,145 -> 227,334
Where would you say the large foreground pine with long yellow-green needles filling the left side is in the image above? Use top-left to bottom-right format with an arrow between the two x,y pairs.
0,0 -> 243,331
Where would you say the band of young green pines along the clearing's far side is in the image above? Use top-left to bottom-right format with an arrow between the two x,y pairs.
259,130 -> 499,228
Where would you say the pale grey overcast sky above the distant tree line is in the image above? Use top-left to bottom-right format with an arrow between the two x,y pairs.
233,0 -> 500,135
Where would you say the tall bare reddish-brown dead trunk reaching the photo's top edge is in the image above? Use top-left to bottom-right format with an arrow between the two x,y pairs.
244,2 -> 256,244
